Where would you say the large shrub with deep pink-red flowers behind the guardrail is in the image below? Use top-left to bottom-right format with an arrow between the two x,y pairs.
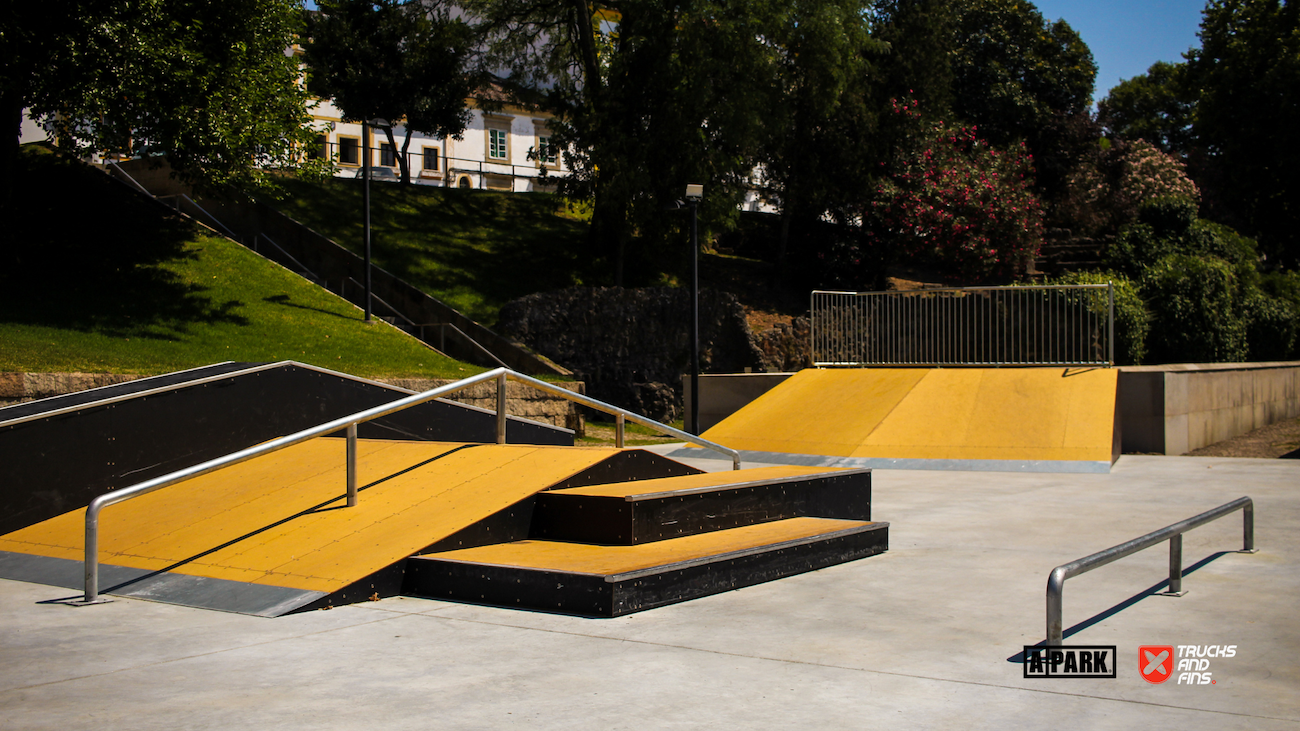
865,101 -> 1043,280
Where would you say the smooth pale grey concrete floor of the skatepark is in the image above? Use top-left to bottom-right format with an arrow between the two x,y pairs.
0,457 -> 1300,731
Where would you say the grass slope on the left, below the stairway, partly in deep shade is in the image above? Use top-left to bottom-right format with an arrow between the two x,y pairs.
0,146 -> 482,377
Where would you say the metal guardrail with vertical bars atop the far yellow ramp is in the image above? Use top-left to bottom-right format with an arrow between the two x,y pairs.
811,284 -> 1115,367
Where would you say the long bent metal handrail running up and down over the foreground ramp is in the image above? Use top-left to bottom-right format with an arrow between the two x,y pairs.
77,368 -> 740,604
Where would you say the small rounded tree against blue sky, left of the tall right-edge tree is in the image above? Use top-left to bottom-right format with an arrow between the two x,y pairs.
1097,61 -> 1196,159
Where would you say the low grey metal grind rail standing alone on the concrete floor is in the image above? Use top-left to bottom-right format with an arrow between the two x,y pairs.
1047,497 -> 1256,646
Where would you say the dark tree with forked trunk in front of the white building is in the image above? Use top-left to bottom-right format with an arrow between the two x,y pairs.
306,0 -> 478,183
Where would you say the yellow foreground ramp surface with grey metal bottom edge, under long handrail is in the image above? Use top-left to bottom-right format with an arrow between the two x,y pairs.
0,438 -> 619,615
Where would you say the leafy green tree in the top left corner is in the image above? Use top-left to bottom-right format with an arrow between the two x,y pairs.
0,0 -> 318,208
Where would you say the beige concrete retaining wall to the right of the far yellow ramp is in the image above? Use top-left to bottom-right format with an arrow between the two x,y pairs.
1118,362 -> 1300,454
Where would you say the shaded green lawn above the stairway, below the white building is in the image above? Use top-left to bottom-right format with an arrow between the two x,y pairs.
272,172 -> 595,326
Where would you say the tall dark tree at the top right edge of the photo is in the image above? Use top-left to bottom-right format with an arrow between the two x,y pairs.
1187,0 -> 1300,267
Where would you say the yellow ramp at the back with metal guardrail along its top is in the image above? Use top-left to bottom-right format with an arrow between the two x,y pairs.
703,368 -> 1118,472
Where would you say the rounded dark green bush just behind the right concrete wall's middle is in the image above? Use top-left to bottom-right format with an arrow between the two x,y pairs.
1141,254 -> 1249,363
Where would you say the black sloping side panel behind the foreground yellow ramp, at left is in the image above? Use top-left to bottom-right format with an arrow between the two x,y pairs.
0,364 -> 573,535
